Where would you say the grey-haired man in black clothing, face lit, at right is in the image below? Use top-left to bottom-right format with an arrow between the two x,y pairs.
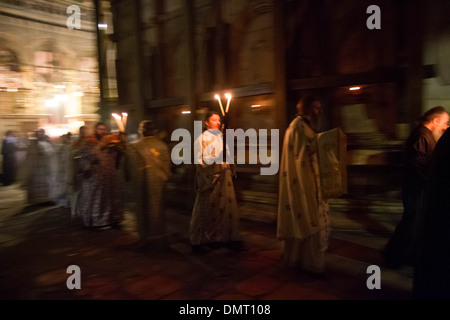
383,107 -> 449,268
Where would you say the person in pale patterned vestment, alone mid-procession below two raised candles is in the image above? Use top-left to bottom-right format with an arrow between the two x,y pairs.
190,113 -> 242,253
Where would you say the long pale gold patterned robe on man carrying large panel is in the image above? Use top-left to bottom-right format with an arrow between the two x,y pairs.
277,117 -> 330,272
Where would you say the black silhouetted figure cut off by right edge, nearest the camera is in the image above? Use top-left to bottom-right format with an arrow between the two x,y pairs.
413,130 -> 450,300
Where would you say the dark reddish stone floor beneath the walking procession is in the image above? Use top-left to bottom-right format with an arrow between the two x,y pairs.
0,186 -> 412,301
